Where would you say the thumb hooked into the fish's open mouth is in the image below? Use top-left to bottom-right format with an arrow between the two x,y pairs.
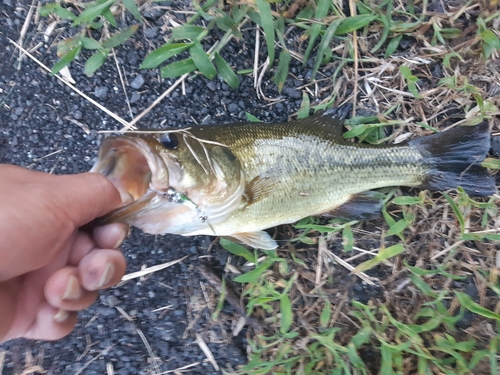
54,173 -> 122,227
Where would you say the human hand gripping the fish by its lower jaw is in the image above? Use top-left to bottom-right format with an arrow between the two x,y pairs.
0,165 -> 128,342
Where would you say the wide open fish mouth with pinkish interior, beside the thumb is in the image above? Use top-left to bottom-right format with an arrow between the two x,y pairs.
90,136 -> 169,224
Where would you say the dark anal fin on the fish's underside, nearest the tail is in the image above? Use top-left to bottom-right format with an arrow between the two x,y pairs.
328,191 -> 384,221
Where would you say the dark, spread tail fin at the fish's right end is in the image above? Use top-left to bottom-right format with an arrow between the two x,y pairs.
409,122 -> 496,196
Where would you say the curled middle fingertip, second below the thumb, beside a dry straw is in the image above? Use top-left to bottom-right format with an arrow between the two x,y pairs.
78,250 -> 127,290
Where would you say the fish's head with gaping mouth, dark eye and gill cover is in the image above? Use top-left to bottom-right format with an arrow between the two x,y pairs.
91,130 -> 245,235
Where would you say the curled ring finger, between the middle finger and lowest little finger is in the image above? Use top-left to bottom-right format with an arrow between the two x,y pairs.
44,266 -> 98,311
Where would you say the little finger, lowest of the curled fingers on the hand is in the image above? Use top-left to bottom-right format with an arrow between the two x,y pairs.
23,302 -> 76,340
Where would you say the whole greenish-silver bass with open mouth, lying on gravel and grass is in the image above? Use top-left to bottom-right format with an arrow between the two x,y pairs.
91,105 -> 496,249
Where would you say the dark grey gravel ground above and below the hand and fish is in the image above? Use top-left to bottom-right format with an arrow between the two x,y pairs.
0,0 -> 333,375
